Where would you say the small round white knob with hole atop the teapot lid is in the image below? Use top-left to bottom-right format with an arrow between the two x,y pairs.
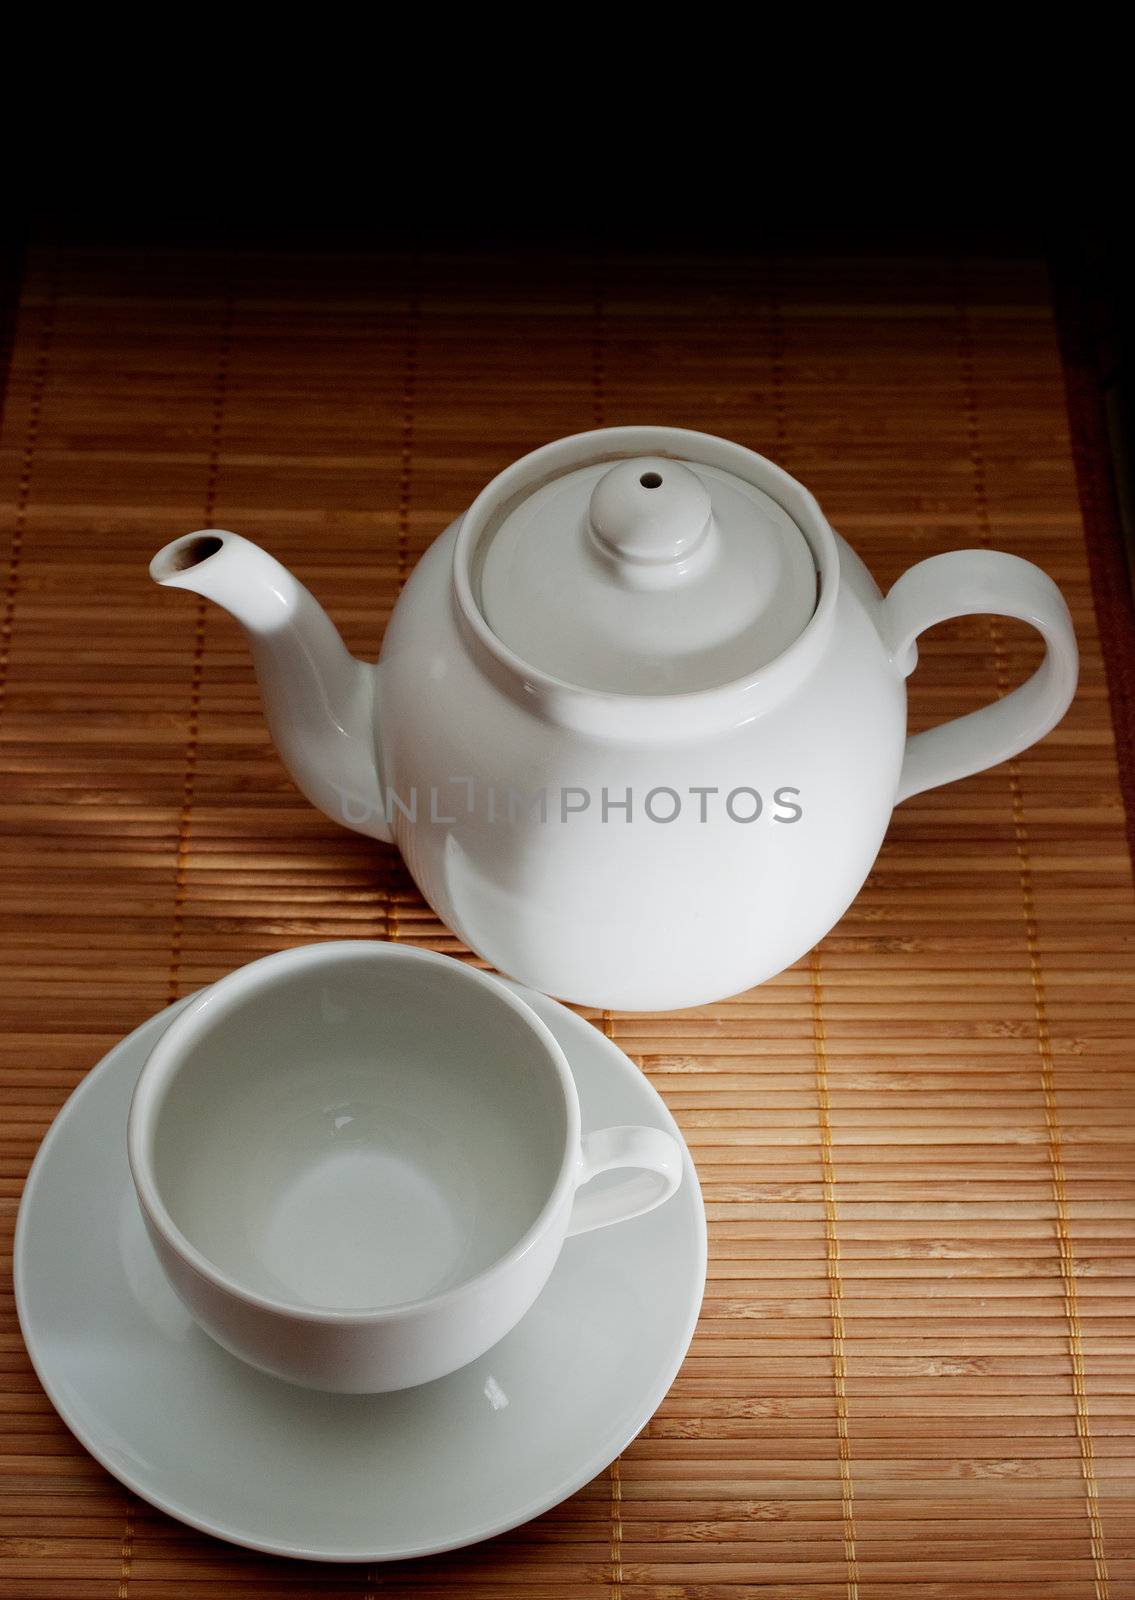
588,456 -> 712,565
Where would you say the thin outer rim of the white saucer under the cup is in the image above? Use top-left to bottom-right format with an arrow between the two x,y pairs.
11,978 -> 709,1566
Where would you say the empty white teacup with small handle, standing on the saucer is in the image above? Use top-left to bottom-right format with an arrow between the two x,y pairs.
128,941 -> 682,1392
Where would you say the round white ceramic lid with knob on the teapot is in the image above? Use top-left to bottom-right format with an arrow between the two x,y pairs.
472,441 -> 818,694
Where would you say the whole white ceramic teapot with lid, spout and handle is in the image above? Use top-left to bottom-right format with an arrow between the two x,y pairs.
150,427 -> 1077,1011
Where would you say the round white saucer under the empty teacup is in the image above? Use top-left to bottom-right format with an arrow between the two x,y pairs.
14,984 -> 706,1562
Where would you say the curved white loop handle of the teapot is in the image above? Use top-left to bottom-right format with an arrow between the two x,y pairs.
884,550 -> 1079,802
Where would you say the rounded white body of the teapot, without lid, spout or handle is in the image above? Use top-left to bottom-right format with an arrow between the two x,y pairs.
376,523 -> 906,1011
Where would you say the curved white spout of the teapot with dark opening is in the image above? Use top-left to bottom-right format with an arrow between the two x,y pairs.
150,528 -> 391,843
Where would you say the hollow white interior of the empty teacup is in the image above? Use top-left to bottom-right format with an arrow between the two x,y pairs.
141,946 -> 570,1312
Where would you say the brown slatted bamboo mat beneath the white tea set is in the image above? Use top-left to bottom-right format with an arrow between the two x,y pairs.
0,248 -> 1135,1600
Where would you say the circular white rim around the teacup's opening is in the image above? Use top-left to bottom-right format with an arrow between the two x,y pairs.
126,939 -> 581,1326
